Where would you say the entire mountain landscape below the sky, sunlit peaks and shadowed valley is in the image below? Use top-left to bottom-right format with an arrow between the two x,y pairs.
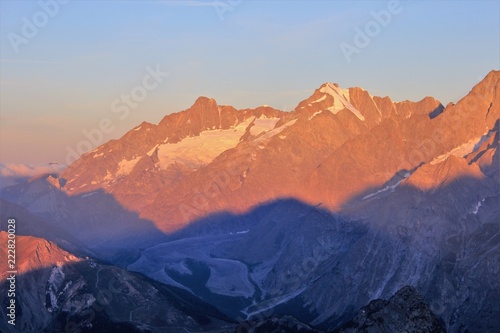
0,71 -> 500,333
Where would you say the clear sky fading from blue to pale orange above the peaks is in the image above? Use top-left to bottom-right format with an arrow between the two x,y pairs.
0,0 -> 500,163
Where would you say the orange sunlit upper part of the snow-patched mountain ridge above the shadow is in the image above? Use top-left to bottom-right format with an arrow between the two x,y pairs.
55,72 -> 498,231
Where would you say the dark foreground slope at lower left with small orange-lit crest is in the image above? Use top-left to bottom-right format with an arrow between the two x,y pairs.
0,232 -> 234,333
